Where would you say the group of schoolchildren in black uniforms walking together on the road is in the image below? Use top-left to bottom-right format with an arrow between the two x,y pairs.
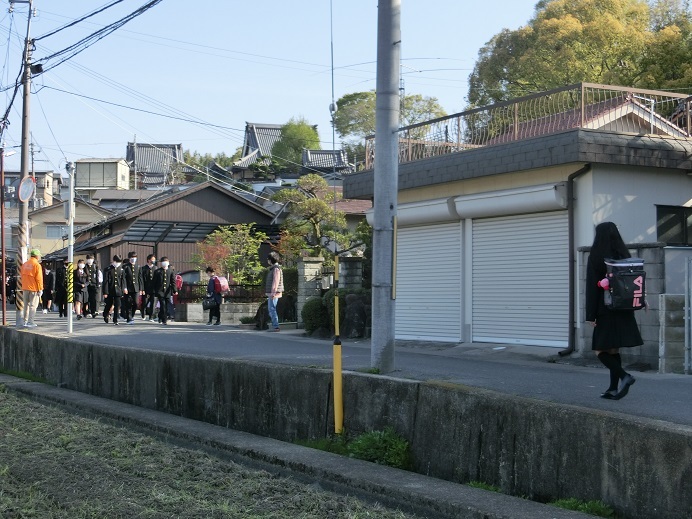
41,252 -> 182,325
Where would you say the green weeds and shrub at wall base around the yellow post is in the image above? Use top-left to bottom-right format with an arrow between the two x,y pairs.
295,427 -> 413,470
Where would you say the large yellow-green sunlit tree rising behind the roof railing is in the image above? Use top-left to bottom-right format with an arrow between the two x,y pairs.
468,0 -> 652,106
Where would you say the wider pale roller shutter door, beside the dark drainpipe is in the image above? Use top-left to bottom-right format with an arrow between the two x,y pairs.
472,211 -> 569,347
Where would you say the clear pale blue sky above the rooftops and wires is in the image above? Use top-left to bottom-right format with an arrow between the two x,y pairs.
0,0 -> 537,175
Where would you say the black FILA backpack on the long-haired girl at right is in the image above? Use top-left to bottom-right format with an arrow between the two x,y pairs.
599,258 -> 646,310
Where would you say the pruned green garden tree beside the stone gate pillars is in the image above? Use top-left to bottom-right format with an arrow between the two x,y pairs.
272,173 -> 362,257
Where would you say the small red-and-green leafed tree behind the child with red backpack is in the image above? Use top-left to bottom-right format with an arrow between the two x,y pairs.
193,223 -> 267,284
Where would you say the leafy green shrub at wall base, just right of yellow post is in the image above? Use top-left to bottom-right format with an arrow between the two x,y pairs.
348,427 -> 412,470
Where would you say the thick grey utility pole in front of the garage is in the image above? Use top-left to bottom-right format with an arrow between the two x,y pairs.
370,0 -> 401,373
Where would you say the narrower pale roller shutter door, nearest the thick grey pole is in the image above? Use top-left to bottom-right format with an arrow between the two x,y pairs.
395,222 -> 462,342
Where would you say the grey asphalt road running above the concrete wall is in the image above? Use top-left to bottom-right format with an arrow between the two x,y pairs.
8,310 -> 692,426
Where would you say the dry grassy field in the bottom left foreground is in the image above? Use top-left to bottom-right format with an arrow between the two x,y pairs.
0,386 -> 422,519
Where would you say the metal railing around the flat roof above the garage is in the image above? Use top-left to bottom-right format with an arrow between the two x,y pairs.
365,83 -> 692,169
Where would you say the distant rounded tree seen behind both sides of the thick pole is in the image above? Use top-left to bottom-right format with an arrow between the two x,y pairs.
334,90 -> 447,140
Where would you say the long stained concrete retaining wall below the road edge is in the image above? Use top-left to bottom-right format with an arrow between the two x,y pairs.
0,327 -> 692,519
